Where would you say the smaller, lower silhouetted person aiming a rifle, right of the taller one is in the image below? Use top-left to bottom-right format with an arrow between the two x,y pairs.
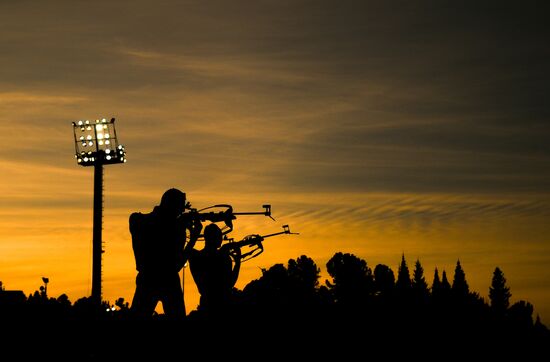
189,223 -> 245,318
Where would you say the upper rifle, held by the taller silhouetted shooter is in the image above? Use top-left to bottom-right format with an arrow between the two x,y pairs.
178,202 -> 275,237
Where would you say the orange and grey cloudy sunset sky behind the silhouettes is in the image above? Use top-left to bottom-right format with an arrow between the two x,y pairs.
0,0 -> 550,324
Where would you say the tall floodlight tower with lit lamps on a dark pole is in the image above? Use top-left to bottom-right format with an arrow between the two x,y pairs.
73,118 -> 126,303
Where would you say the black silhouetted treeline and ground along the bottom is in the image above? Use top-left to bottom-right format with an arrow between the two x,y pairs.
0,252 -> 550,359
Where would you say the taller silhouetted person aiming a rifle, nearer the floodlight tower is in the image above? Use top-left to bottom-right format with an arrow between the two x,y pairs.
129,188 -> 202,318
